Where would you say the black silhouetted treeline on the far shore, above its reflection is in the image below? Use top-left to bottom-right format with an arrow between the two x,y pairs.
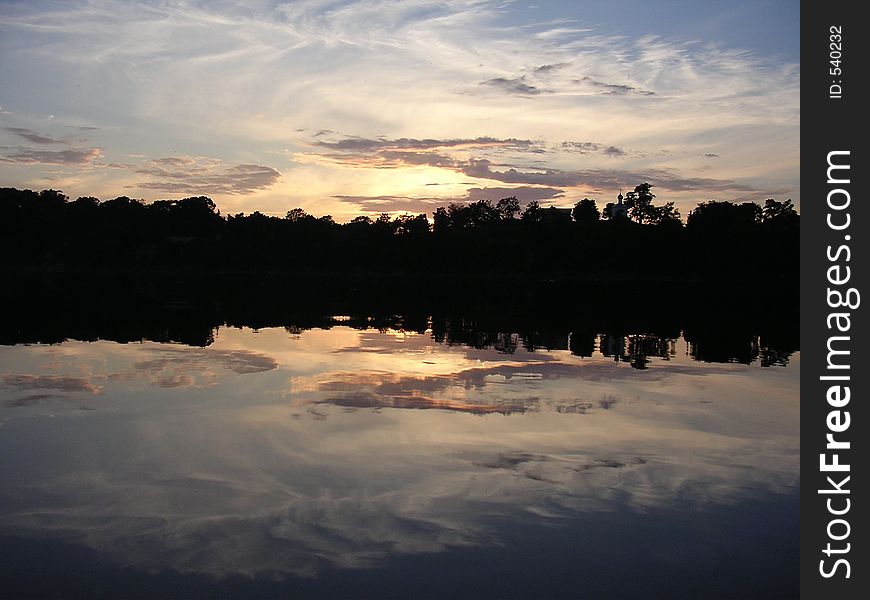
0,183 -> 800,282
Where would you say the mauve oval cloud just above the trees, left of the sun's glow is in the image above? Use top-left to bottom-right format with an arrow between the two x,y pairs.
135,156 -> 281,196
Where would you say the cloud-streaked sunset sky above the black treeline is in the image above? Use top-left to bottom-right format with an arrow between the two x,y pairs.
0,0 -> 800,222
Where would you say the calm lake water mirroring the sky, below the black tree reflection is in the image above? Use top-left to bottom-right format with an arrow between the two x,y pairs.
0,318 -> 800,599
